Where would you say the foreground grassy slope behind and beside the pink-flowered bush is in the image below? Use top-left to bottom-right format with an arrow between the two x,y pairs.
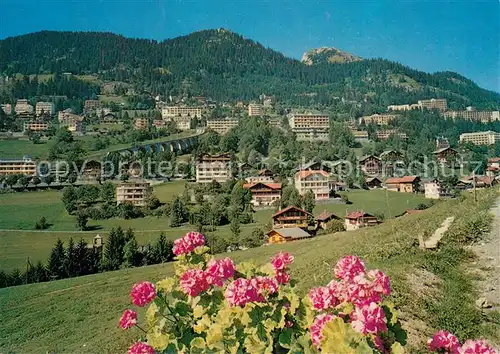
0,192 -> 500,353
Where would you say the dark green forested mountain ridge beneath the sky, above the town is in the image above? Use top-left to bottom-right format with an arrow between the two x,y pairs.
0,30 -> 500,111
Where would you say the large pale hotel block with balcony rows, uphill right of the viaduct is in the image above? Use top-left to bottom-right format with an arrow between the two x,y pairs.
288,114 -> 330,141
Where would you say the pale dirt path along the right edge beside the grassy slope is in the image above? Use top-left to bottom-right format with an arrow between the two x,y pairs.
472,198 -> 500,311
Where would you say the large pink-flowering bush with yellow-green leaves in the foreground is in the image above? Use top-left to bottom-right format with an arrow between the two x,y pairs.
120,232 -> 406,353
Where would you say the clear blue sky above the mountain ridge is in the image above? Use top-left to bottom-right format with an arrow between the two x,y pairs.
0,0 -> 500,92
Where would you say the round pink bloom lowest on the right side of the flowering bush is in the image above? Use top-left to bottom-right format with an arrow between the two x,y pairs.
351,302 -> 387,334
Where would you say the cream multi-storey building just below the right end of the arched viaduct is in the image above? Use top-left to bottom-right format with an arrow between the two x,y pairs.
196,154 -> 231,183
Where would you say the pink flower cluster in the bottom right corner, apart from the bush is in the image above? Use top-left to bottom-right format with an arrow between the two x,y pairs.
428,330 -> 498,354
